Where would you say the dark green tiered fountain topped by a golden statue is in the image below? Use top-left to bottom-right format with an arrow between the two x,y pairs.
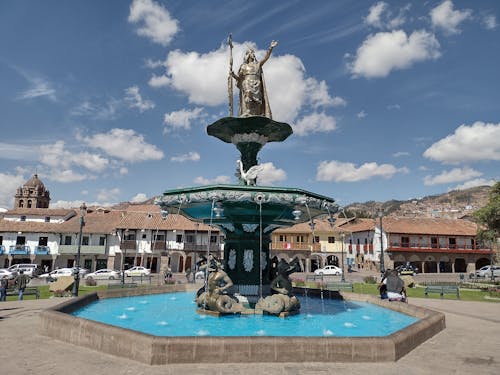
156,42 -> 337,316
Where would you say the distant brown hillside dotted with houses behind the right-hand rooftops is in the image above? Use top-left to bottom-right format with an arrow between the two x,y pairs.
345,186 -> 491,219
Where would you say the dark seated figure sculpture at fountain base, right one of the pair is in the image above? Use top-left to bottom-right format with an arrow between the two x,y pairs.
255,258 -> 300,315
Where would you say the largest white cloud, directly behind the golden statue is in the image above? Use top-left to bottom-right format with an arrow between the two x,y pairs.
149,42 -> 340,122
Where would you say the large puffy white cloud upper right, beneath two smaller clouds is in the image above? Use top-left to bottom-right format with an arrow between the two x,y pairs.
348,30 -> 440,78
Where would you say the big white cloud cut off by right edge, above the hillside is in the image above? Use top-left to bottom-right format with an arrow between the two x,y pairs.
423,121 -> 500,163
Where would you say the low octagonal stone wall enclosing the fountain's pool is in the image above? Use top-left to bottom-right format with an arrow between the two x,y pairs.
40,285 -> 445,365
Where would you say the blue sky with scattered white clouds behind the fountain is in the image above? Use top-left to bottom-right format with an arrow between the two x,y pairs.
0,0 -> 500,208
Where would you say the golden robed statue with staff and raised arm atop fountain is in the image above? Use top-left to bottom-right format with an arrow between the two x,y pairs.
229,40 -> 278,118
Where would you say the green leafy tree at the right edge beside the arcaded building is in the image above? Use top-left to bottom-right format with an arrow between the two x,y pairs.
474,181 -> 500,260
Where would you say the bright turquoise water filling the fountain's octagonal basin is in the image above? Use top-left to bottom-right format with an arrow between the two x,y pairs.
73,292 -> 418,337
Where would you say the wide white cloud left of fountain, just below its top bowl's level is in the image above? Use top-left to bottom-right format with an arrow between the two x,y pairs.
82,128 -> 163,162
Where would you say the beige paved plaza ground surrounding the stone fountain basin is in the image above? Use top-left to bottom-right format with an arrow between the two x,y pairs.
0,298 -> 500,375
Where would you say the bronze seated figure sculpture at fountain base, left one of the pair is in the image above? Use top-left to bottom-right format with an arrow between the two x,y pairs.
196,257 -> 243,314
